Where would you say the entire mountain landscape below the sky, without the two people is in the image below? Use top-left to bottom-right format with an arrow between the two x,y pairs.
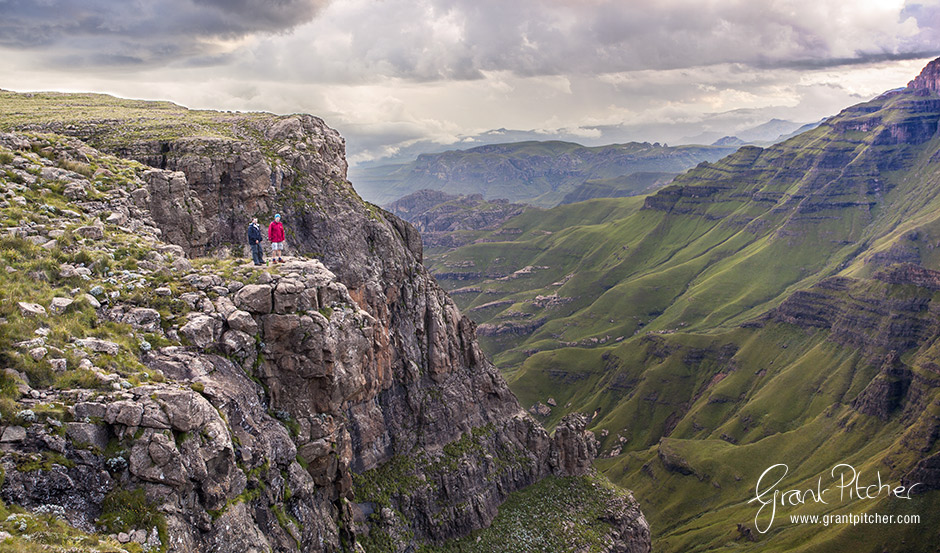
0,55 -> 940,553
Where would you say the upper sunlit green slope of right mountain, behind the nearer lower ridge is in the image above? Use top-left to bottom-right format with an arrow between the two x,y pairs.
429,88 -> 940,370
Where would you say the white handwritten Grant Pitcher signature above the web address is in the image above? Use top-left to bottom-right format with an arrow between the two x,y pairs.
748,463 -> 920,534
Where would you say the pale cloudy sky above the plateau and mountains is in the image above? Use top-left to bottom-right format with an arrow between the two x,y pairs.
0,0 -> 940,163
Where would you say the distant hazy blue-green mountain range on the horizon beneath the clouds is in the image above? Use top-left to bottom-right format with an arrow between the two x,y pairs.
350,141 -> 737,207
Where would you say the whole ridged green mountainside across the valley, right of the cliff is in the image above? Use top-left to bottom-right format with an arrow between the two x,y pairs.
426,60 -> 940,551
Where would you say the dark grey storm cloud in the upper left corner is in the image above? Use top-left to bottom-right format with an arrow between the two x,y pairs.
0,0 -> 326,67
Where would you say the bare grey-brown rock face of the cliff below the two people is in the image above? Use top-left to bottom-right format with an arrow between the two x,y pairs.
3,116 -> 648,552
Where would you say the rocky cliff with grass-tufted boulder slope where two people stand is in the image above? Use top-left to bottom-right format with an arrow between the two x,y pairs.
0,92 -> 649,551
